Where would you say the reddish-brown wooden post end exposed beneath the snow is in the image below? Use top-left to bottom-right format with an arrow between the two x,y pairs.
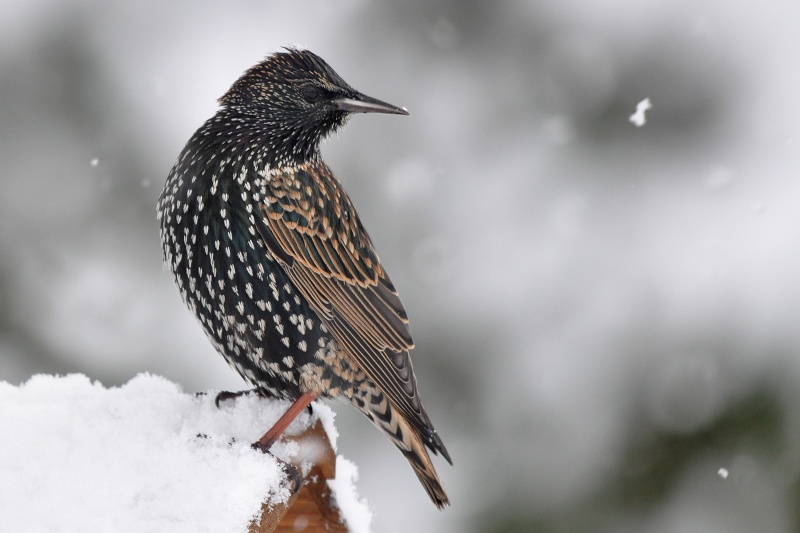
249,421 -> 347,533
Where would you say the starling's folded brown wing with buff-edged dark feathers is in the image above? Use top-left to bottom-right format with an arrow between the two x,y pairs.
258,164 -> 430,430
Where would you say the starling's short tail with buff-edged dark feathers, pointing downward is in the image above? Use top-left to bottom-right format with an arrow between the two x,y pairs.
353,391 -> 452,509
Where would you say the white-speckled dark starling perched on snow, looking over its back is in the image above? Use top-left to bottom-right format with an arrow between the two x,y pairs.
157,47 -> 452,509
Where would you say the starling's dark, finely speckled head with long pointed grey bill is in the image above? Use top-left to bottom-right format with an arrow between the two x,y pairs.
220,48 -> 409,161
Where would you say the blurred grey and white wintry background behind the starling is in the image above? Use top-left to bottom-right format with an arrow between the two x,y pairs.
0,0 -> 800,533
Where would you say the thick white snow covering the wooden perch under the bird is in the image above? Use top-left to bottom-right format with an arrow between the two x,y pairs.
0,374 -> 371,533
